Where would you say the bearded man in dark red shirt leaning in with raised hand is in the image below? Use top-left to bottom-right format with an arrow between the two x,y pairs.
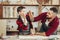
29,7 -> 59,36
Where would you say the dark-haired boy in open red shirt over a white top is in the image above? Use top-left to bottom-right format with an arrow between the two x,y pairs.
16,6 -> 33,34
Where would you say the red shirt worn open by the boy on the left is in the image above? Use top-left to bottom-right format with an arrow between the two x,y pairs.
16,14 -> 33,30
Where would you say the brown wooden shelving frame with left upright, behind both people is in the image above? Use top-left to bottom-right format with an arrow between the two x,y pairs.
0,4 -> 60,19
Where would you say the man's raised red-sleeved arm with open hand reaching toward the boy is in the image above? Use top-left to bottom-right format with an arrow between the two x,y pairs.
29,11 -> 47,22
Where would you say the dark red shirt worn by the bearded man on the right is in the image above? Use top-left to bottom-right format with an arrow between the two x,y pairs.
34,12 -> 59,36
